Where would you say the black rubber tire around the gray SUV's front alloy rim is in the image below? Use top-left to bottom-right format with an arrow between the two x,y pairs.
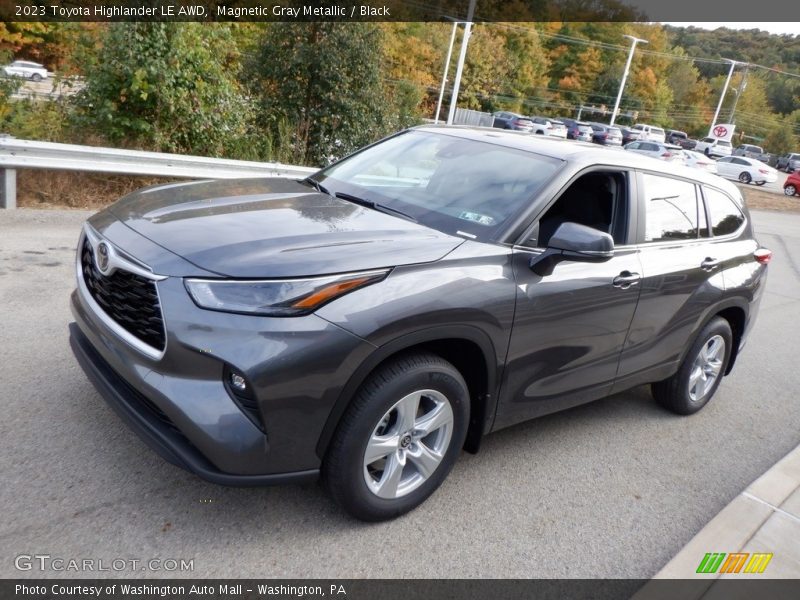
322,352 -> 470,521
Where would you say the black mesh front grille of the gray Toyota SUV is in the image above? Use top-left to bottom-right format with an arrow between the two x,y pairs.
81,239 -> 166,350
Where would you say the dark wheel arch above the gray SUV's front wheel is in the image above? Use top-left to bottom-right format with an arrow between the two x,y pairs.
317,325 -> 500,458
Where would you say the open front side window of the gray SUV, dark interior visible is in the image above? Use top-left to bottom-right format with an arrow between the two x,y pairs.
529,171 -> 628,248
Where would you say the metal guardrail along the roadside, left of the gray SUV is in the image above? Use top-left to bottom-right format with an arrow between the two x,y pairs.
0,137 -> 318,208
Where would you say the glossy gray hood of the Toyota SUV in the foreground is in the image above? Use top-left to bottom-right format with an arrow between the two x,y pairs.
103,178 -> 464,278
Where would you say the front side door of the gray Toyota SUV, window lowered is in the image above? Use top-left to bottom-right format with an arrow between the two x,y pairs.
495,171 -> 642,427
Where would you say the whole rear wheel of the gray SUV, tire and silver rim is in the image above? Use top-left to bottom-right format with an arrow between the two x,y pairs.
651,317 -> 733,415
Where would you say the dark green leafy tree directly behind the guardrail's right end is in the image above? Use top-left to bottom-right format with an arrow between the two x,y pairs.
250,22 -> 392,165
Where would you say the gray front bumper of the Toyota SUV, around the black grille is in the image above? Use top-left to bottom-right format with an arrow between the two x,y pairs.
70,223 -> 375,485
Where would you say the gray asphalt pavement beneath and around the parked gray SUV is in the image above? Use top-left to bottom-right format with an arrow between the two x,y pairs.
0,210 -> 800,577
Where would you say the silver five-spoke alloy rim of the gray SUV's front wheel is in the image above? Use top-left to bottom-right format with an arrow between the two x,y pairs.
364,390 -> 453,500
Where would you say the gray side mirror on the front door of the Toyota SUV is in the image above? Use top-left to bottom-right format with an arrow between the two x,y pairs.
530,222 -> 614,277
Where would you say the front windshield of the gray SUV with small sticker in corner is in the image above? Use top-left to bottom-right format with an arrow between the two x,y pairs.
314,130 -> 563,241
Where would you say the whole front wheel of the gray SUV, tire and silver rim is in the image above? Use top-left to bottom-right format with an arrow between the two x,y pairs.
322,352 -> 470,521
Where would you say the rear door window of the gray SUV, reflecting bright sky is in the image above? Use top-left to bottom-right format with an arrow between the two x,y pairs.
642,174 -> 700,242
